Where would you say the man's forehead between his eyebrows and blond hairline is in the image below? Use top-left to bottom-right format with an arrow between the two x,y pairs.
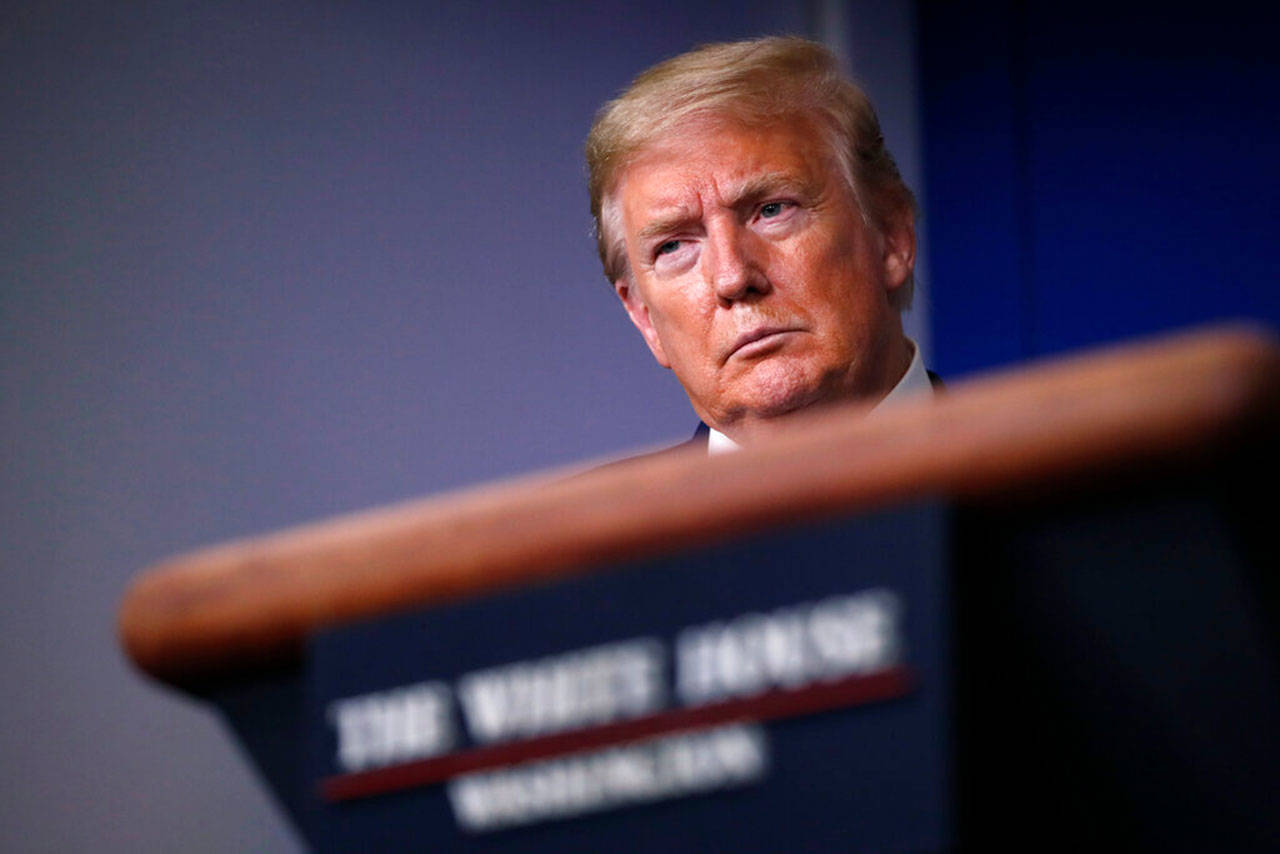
614,118 -> 838,224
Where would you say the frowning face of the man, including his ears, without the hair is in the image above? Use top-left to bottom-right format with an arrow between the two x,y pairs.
614,120 -> 915,437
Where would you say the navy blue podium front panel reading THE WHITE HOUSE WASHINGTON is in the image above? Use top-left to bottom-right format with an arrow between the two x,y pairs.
303,504 -> 952,851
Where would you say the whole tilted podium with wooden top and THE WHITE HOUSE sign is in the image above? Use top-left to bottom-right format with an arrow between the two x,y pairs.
120,328 -> 1280,851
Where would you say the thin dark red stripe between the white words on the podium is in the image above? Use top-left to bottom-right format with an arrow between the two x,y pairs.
320,667 -> 914,802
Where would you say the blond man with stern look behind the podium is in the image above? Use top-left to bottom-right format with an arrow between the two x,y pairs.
586,37 -> 929,452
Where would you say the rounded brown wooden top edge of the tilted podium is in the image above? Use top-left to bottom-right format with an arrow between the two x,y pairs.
119,326 -> 1280,686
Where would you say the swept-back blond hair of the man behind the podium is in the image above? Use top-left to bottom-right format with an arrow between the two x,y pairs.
586,36 -> 915,309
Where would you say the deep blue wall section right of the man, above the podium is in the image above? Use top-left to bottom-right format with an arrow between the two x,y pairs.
920,3 -> 1280,375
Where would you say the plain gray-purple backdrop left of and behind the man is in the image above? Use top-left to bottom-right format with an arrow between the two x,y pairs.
0,0 -> 927,851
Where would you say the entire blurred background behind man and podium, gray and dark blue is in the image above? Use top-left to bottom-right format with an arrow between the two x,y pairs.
0,0 -> 1280,851
